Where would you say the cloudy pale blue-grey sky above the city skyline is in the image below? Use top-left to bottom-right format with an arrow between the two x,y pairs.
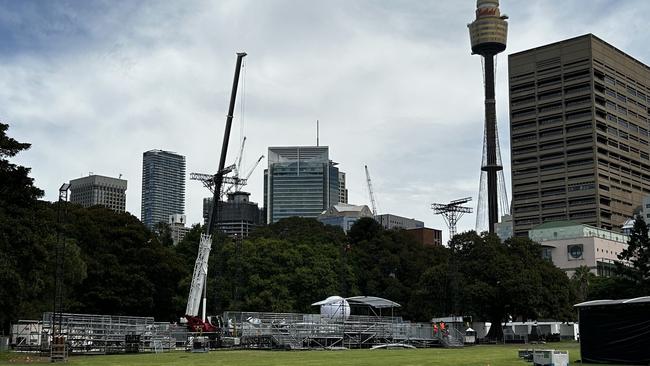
0,0 -> 650,241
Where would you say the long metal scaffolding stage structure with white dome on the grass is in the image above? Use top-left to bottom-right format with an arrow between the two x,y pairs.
10,296 -> 464,357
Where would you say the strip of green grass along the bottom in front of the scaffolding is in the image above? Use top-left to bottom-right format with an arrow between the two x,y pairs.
0,342 -> 616,366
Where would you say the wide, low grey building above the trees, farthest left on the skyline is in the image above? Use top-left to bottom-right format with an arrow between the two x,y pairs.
70,175 -> 127,212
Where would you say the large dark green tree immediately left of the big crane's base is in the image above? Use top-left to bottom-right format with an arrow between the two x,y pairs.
66,206 -> 188,321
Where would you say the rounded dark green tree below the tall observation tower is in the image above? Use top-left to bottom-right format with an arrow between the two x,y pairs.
450,232 -> 573,340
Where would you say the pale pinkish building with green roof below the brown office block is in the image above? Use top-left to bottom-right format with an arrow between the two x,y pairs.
528,221 -> 628,277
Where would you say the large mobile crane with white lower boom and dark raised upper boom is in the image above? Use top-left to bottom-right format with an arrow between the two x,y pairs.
185,52 -> 246,332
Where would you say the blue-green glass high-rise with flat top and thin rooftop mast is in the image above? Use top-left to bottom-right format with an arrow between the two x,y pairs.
264,146 -> 339,224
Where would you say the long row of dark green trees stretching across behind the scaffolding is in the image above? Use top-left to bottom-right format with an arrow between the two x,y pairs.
0,124 -> 648,338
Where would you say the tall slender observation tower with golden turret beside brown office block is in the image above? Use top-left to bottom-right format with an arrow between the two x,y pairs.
468,0 -> 509,233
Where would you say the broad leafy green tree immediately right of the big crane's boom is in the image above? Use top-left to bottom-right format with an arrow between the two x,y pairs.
206,217 -> 354,312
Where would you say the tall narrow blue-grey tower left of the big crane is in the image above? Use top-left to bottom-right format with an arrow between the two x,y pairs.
140,150 -> 185,229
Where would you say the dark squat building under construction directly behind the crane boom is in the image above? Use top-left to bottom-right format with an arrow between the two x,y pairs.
203,191 -> 263,238
